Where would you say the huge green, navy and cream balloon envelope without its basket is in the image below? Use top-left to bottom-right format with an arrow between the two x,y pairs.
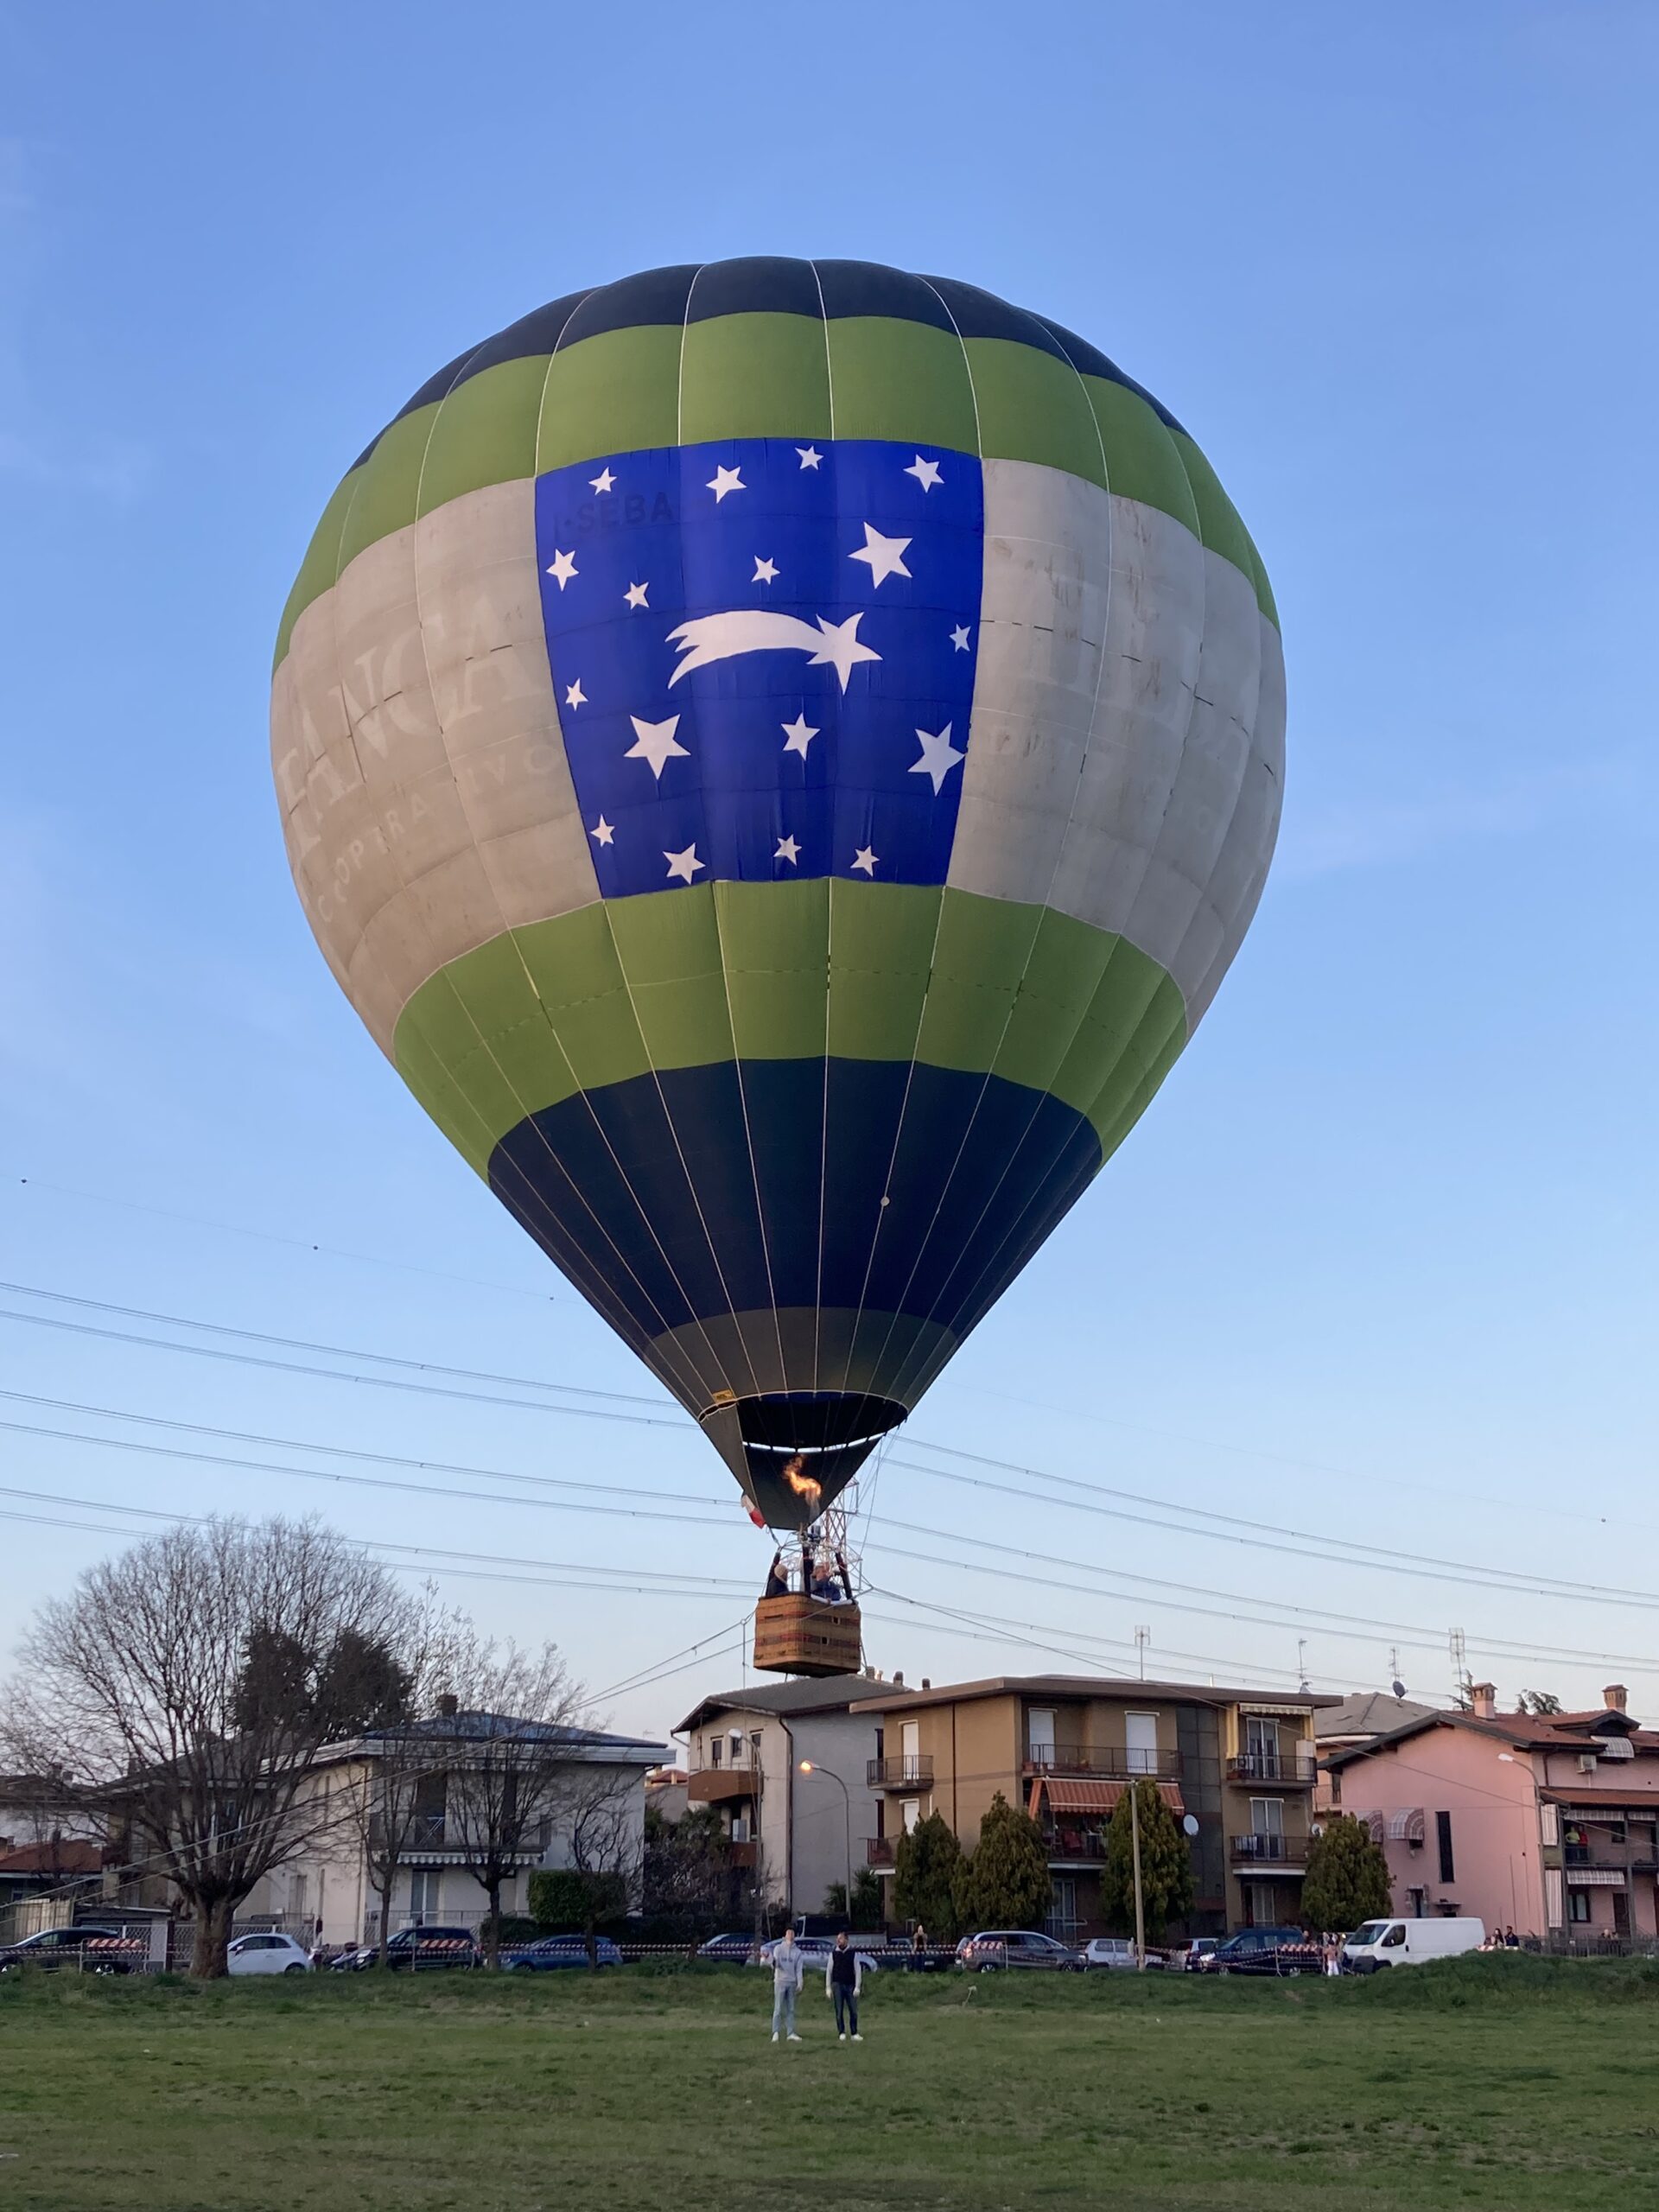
272,259 -> 1285,1531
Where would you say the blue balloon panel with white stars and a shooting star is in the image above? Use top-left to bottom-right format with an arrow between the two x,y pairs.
536,438 -> 984,898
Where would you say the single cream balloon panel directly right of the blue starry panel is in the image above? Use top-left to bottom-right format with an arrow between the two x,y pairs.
949,460 -> 1113,902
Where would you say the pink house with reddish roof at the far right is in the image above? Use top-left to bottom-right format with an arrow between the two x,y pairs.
1325,1683 -> 1659,1947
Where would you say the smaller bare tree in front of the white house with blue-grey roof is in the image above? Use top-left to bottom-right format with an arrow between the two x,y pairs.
429,1624 -> 584,1967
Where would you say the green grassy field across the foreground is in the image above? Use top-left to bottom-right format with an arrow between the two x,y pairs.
0,1955 -> 1659,2212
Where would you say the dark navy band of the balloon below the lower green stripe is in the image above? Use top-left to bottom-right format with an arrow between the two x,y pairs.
489,1059 -> 1102,1344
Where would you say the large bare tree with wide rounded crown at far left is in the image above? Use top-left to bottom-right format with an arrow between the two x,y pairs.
11,1520 -> 411,1980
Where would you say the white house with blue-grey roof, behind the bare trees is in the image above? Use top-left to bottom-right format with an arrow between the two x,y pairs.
238,1712 -> 666,1944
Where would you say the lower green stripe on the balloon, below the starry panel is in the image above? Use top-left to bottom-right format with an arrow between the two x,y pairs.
394,878 -> 1185,1174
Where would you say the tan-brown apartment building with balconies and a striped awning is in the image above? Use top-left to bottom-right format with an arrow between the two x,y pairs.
852,1675 -> 1338,1938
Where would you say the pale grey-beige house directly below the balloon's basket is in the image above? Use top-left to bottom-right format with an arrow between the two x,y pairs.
675,1675 -> 929,1913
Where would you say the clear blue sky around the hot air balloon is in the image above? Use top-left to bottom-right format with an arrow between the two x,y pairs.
0,0 -> 1659,1727
